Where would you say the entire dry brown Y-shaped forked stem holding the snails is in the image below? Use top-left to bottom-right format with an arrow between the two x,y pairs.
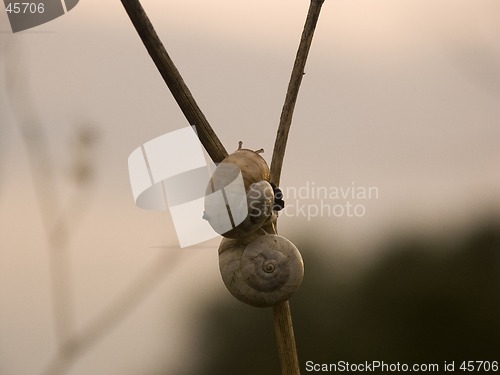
121,0 -> 324,375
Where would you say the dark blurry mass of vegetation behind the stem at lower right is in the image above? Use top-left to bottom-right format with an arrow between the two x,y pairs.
193,219 -> 500,375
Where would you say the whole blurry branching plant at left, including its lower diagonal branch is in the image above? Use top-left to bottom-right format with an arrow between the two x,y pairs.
0,35 -> 184,375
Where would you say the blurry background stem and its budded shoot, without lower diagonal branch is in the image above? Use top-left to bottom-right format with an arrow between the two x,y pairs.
3,36 -> 99,374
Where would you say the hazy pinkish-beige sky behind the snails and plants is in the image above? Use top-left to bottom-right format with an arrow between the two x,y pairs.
0,0 -> 500,375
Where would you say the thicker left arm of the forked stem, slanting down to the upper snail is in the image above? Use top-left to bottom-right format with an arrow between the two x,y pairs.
121,0 -> 227,163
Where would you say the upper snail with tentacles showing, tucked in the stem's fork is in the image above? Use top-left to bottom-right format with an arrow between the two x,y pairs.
203,141 -> 276,238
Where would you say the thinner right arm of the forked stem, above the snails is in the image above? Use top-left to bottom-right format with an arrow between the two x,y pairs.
270,0 -> 324,185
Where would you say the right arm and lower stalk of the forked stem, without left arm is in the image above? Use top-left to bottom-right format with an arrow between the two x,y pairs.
270,0 -> 324,375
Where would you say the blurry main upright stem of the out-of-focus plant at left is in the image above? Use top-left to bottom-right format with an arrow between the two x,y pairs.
6,47 -> 74,348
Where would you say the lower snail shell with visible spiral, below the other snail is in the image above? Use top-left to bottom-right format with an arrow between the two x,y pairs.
219,231 -> 304,307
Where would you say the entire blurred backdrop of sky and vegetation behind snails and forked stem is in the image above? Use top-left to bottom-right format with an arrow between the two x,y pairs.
0,0 -> 500,375
